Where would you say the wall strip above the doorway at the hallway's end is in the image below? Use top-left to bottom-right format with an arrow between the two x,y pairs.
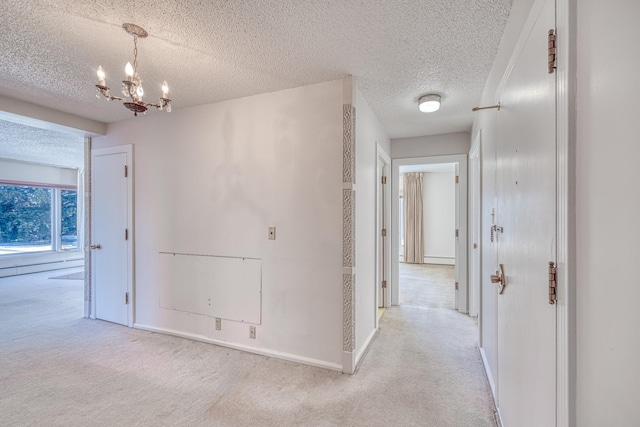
391,132 -> 471,159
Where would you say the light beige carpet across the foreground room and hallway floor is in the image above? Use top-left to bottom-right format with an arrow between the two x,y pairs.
0,274 -> 495,427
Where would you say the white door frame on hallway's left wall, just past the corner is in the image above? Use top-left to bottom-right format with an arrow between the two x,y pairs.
375,144 -> 393,329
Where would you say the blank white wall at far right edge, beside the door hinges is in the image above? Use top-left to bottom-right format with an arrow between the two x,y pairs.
575,0 -> 640,426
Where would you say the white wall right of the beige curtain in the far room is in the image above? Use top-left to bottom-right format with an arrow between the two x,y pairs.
423,172 -> 456,264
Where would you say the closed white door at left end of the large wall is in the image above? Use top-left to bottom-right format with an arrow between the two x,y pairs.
91,147 -> 133,325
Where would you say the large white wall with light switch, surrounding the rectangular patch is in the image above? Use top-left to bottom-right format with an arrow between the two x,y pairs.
93,80 -> 344,370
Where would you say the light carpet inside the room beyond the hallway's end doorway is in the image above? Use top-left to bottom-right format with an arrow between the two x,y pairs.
400,263 -> 456,310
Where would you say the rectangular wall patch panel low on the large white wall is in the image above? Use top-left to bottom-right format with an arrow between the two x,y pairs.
159,252 -> 262,325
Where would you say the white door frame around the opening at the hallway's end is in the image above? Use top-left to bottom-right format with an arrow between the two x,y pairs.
390,154 -> 468,313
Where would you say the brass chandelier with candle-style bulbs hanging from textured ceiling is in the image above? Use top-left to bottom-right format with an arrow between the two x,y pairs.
96,24 -> 171,116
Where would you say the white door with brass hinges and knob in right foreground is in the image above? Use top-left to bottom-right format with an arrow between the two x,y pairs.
496,0 -> 556,427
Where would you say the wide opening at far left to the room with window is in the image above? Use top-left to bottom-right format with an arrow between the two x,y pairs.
0,115 -> 84,277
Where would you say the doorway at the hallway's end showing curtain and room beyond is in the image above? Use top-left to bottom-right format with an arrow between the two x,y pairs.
391,155 -> 468,313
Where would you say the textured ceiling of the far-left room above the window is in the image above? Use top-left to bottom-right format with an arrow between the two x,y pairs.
0,120 -> 84,168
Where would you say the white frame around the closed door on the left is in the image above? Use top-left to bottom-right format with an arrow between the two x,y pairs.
88,144 -> 135,328
